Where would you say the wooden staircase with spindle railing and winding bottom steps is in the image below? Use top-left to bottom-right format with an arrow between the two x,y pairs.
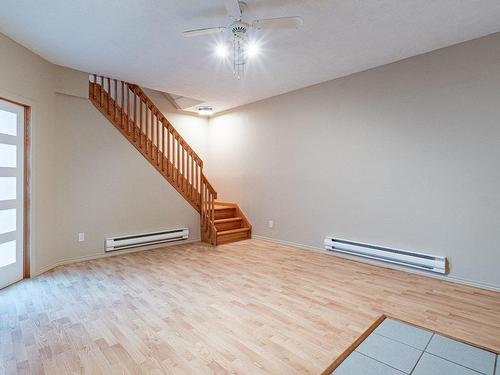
89,75 -> 252,245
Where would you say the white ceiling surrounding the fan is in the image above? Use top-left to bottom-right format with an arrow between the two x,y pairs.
0,0 -> 500,111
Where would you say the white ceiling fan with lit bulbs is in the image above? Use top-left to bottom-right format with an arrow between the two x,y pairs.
182,0 -> 303,79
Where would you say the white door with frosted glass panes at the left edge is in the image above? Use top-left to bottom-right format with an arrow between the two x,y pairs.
0,99 -> 24,288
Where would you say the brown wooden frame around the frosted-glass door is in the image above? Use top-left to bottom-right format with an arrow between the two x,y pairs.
0,96 -> 31,279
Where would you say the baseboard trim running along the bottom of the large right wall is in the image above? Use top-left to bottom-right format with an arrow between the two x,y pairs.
252,235 -> 500,292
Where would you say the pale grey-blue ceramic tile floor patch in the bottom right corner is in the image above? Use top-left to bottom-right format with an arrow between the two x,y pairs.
332,319 -> 500,375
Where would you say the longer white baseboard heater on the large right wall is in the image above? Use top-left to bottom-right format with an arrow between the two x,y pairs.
325,236 -> 446,274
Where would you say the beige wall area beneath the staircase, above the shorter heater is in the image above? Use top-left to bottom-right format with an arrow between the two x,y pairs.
53,90 -> 200,268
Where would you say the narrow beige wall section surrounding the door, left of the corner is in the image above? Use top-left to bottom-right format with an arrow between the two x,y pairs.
0,34 -> 56,271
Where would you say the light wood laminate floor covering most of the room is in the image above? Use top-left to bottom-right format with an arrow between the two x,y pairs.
0,240 -> 500,375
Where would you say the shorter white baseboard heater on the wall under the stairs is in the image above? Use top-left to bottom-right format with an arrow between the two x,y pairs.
104,228 -> 189,251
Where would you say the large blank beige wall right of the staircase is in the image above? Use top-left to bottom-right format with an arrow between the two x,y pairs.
207,34 -> 500,288
